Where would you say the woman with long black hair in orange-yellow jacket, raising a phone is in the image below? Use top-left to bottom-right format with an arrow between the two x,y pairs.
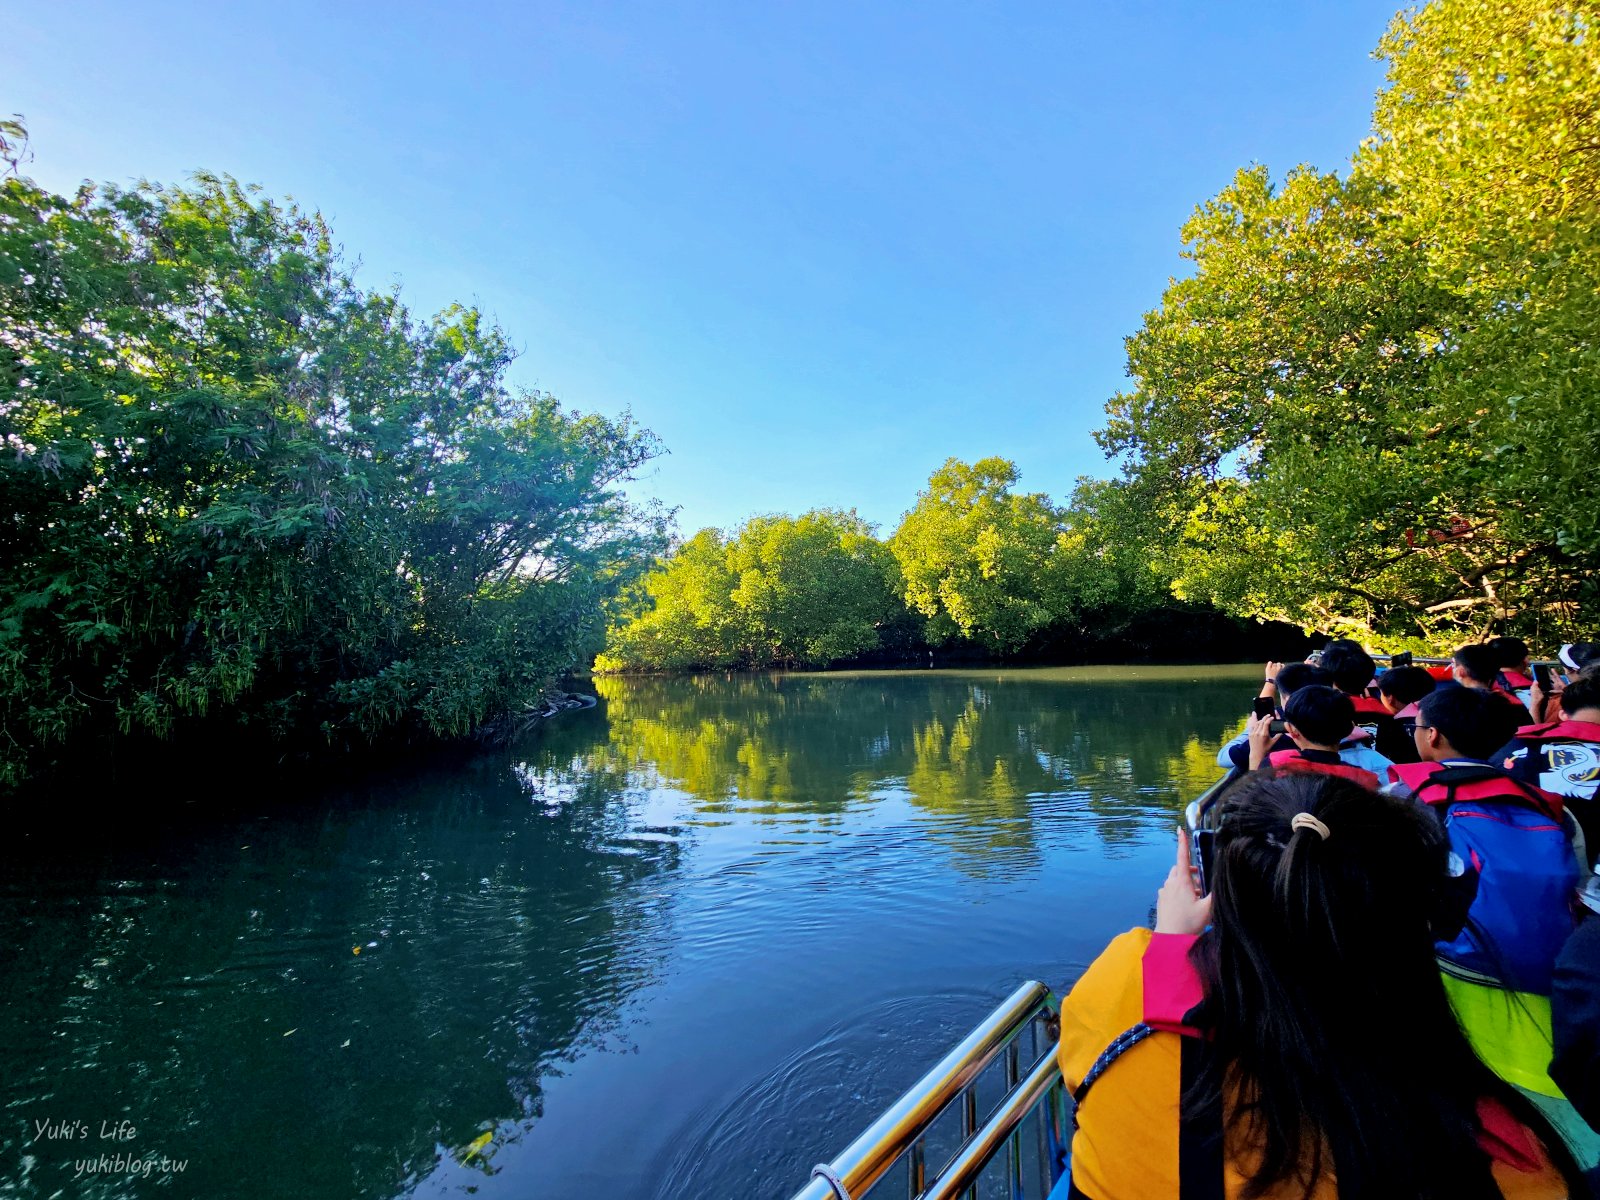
1059,774 -> 1587,1200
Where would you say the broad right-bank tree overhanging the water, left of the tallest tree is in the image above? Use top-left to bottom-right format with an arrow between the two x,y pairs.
1099,168 -> 1456,643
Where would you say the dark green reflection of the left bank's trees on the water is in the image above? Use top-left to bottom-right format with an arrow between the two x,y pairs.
0,718 -> 682,1197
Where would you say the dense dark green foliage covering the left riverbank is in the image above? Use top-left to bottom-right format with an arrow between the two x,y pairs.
0,162 -> 662,782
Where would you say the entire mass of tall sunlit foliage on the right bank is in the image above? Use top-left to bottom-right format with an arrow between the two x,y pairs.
1099,0 -> 1600,645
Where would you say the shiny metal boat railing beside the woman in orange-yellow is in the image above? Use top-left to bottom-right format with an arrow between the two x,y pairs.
794,982 -> 1066,1200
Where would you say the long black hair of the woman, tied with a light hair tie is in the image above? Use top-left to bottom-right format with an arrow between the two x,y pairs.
1184,774 -> 1582,1200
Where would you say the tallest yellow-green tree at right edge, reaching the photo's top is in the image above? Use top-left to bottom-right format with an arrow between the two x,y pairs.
1362,0 -> 1600,614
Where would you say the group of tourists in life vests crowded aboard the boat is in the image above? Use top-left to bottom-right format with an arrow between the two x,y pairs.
1058,637 -> 1600,1200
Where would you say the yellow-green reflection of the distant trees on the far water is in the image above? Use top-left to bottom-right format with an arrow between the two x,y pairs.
595,667 -> 1248,869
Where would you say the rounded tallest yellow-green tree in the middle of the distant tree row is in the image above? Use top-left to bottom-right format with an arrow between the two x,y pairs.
890,458 -> 1062,651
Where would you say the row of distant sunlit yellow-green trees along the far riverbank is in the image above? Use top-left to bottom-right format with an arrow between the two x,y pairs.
595,458 -> 1235,670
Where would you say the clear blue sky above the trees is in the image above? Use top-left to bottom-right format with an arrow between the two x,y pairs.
9,0 -> 1395,533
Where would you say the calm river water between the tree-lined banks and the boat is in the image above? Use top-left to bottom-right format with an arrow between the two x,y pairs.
0,667 -> 1258,1200
